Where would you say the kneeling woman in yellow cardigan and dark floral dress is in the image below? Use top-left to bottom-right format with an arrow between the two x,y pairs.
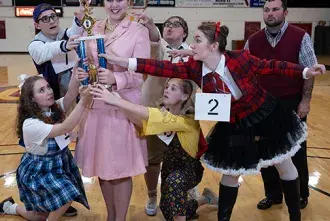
91,78 -> 218,221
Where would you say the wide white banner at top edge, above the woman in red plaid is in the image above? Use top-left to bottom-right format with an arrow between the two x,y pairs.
175,0 -> 249,8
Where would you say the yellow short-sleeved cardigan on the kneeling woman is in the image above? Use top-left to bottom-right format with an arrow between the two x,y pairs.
141,108 -> 200,158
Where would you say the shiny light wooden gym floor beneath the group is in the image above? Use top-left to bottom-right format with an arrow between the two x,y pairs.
0,54 -> 330,221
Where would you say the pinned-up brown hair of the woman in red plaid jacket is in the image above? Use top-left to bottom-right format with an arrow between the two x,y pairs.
198,22 -> 229,53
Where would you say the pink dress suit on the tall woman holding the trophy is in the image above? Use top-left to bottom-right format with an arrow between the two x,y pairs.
75,19 -> 150,180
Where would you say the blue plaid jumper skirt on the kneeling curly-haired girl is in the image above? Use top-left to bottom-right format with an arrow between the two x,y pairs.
16,139 -> 89,212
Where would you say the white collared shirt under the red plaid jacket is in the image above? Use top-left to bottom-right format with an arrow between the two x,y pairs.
201,55 -> 242,100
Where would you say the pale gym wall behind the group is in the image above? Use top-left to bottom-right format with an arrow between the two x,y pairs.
0,7 -> 330,52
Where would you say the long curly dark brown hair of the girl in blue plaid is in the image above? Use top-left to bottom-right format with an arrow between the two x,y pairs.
16,76 -> 65,138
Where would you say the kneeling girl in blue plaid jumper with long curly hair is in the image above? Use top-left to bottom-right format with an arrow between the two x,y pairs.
0,72 -> 90,220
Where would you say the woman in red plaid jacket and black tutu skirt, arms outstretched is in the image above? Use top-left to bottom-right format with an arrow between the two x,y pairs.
97,22 -> 325,221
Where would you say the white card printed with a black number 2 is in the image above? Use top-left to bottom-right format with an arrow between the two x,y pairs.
195,93 -> 231,122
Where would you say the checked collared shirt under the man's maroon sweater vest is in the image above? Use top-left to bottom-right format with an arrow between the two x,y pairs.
245,21 -> 317,67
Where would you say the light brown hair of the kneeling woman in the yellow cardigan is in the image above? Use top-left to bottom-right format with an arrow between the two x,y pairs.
158,78 -> 196,115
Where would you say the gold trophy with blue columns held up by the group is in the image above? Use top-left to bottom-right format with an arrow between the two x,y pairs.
77,0 -> 107,86
